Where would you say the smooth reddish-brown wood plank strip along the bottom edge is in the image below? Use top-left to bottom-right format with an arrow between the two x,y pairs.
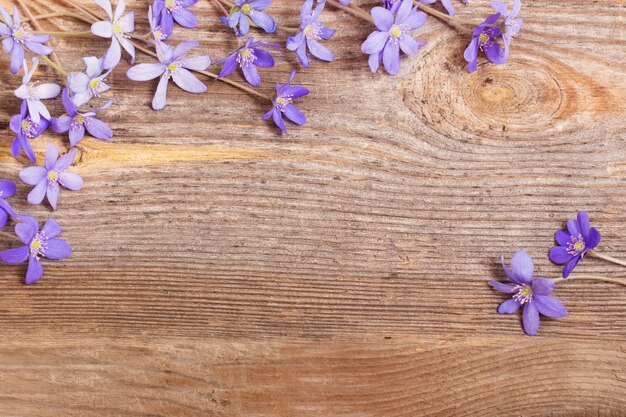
0,338 -> 626,417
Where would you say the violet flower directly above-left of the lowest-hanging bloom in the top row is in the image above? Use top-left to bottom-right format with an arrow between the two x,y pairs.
216,37 -> 281,87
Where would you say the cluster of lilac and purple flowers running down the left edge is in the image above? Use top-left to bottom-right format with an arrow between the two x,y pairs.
0,0 -> 119,284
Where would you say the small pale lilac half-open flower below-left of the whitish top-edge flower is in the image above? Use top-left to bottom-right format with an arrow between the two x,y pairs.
67,56 -> 112,107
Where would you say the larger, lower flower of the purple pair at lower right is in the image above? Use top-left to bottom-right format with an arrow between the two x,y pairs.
489,250 -> 567,336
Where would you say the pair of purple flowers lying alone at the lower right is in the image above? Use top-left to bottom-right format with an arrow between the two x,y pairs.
490,211 -> 600,336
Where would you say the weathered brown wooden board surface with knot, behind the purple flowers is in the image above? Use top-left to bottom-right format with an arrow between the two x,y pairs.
0,0 -> 626,417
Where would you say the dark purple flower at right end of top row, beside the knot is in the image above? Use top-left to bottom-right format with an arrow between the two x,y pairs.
463,13 -> 506,72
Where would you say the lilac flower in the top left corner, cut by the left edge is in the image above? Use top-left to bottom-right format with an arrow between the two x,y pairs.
0,5 -> 52,74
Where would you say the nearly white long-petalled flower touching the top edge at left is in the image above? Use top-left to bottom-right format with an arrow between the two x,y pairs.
91,0 -> 135,69
